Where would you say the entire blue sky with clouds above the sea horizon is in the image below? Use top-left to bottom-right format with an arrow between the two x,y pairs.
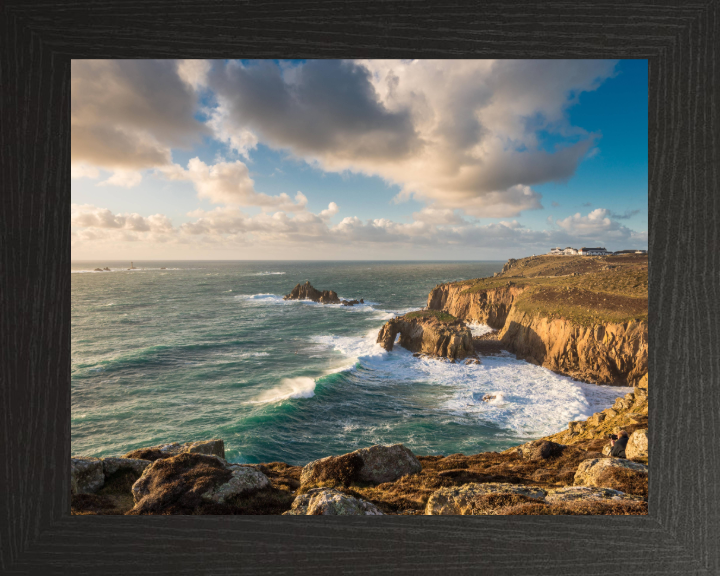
71,60 -> 648,261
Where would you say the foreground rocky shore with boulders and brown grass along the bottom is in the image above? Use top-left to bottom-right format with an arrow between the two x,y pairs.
71,380 -> 648,515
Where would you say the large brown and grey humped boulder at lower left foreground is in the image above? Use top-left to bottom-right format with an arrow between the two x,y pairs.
128,452 -> 270,515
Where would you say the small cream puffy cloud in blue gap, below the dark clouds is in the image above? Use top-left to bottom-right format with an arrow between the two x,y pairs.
159,158 -> 307,212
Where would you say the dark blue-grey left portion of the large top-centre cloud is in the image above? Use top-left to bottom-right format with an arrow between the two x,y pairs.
208,60 -> 420,163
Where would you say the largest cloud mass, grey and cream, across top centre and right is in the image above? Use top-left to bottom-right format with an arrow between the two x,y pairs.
201,60 -> 615,217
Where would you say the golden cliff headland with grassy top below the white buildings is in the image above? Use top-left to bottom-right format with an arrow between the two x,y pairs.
427,257 -> 648,386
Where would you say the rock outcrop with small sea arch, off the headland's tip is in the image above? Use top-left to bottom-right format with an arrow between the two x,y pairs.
377,313 -> 475,360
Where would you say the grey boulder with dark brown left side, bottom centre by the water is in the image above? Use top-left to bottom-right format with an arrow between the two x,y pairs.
300,444 -> 422,486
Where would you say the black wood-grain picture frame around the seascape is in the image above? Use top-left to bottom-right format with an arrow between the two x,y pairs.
0,0 -> 720,576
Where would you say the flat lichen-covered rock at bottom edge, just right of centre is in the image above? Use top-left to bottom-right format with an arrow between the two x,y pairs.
425,482 -> 546,516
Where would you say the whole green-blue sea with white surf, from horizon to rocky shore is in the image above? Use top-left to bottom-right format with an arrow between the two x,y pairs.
72,261 -> 626,464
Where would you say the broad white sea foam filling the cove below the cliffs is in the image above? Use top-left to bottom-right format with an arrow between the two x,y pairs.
313,330 -> 628,438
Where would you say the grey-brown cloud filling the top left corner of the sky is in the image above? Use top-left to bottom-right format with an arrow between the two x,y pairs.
70,60 -> 210,170
